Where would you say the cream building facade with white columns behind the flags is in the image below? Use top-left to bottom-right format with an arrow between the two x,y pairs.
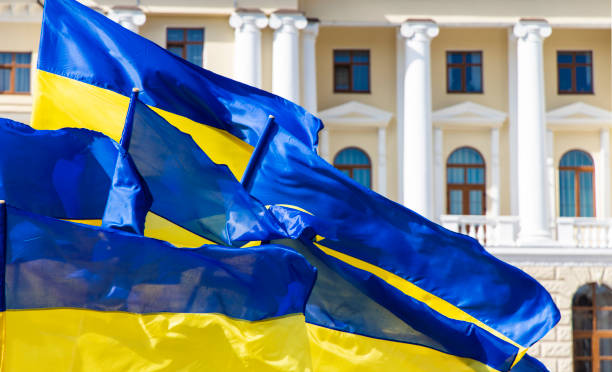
0,0 -> 612,371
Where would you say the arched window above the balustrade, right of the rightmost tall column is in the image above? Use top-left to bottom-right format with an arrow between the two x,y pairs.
559,150 -> 595,217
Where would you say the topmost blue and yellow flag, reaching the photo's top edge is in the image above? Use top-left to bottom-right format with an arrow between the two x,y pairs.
32,0 -> 322,178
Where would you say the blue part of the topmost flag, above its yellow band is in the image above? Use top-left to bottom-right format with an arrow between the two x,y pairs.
38,0 -> 322,149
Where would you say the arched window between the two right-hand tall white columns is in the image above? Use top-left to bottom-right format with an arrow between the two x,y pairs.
446,147 -> 486,214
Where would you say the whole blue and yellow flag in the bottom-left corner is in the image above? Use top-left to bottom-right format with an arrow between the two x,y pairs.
0,202 -> 315,372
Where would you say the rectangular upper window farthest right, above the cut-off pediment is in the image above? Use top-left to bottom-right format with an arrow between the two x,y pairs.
557,51 -> 593,94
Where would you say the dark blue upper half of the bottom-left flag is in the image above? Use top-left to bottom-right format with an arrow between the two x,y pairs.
0,206 -> 316,321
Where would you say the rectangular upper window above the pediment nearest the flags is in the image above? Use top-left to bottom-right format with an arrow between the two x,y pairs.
334,50 -> 370,93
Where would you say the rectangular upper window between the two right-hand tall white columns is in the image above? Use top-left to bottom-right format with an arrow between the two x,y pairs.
446,52 -> 482,93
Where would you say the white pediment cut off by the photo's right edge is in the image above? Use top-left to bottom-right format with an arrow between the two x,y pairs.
546,102 -> 612,129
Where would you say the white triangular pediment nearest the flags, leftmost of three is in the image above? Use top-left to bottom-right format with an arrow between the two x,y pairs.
318,101 -> 393,128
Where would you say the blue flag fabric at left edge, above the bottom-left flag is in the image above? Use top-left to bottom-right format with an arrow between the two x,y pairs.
0,119 -> 119,219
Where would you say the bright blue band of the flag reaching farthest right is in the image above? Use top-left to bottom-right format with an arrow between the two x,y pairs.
245,119 -> 560,347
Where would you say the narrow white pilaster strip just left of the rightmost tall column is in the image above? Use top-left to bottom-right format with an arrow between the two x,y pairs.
508,28 -> 518,216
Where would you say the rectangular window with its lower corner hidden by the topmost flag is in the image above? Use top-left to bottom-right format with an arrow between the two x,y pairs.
166,28 -> 204,67
